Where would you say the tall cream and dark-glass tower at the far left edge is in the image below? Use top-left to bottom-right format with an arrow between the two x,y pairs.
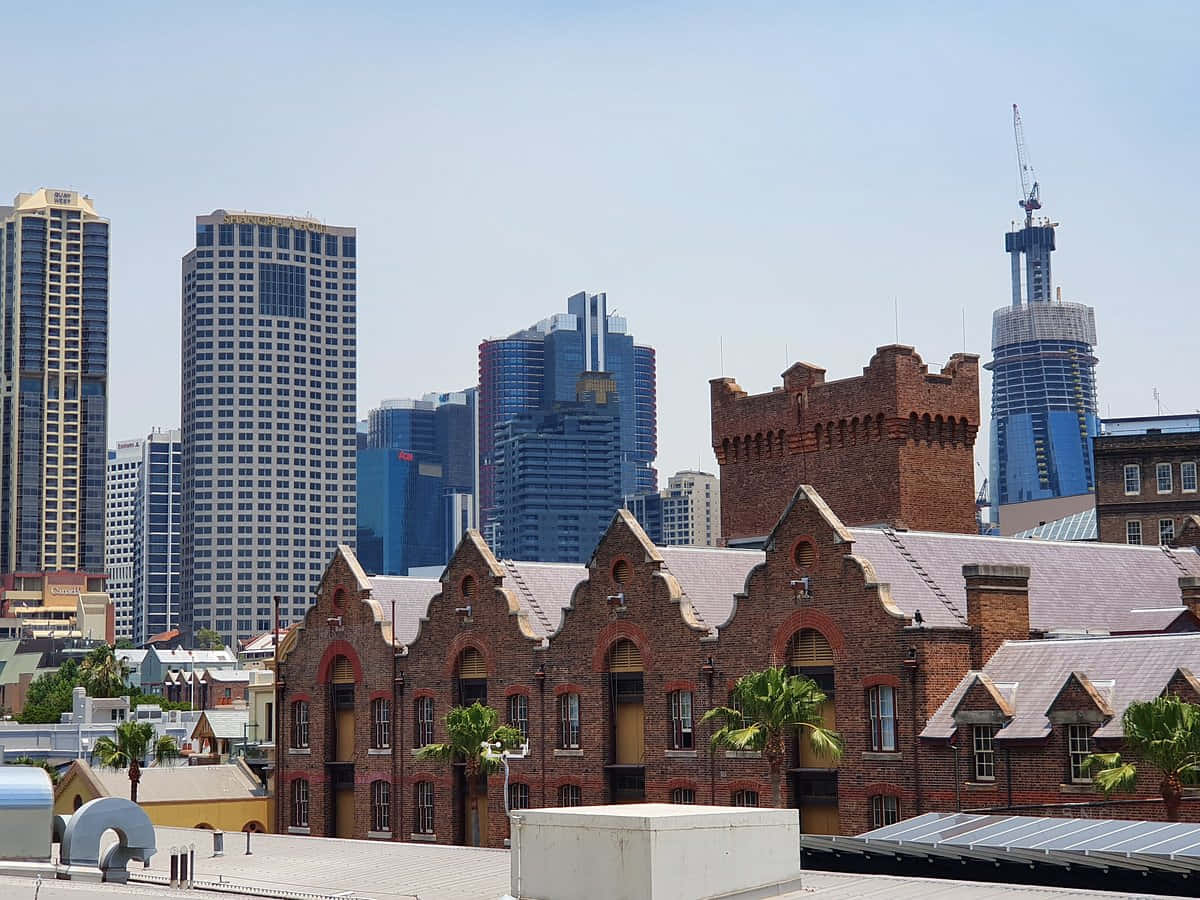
0,188 -> 109,575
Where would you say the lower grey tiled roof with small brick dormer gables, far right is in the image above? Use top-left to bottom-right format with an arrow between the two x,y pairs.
922,632 -> 1200,738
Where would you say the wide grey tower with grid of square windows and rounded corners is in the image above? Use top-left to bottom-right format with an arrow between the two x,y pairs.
180,210 -> 358,642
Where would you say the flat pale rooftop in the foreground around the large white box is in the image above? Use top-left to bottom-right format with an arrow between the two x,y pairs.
0,828 -> 1180,900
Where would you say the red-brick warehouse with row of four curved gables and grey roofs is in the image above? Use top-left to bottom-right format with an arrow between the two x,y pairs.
277,486 -> 1200,846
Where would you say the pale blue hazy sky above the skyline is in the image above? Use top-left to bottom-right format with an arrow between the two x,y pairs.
0,0 -> 1200,494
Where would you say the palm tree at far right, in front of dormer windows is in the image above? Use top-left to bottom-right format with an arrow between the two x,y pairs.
1087,694 -> 1200,822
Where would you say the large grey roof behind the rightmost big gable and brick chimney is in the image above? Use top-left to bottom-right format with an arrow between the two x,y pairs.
850,528 -> 1200,632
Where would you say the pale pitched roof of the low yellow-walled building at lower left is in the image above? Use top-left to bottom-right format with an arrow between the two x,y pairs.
60,760 -> 266,804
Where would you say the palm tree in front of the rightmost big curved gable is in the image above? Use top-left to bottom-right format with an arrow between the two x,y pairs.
700,666 -> 842,809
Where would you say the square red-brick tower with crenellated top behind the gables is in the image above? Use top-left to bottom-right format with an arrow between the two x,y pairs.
710,344 -> 979,544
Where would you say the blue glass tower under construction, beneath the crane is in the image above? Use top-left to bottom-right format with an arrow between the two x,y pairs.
985,214 -> 1099,533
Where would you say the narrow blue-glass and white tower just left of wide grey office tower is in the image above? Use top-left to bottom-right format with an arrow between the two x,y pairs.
132,428 -> 184,646
